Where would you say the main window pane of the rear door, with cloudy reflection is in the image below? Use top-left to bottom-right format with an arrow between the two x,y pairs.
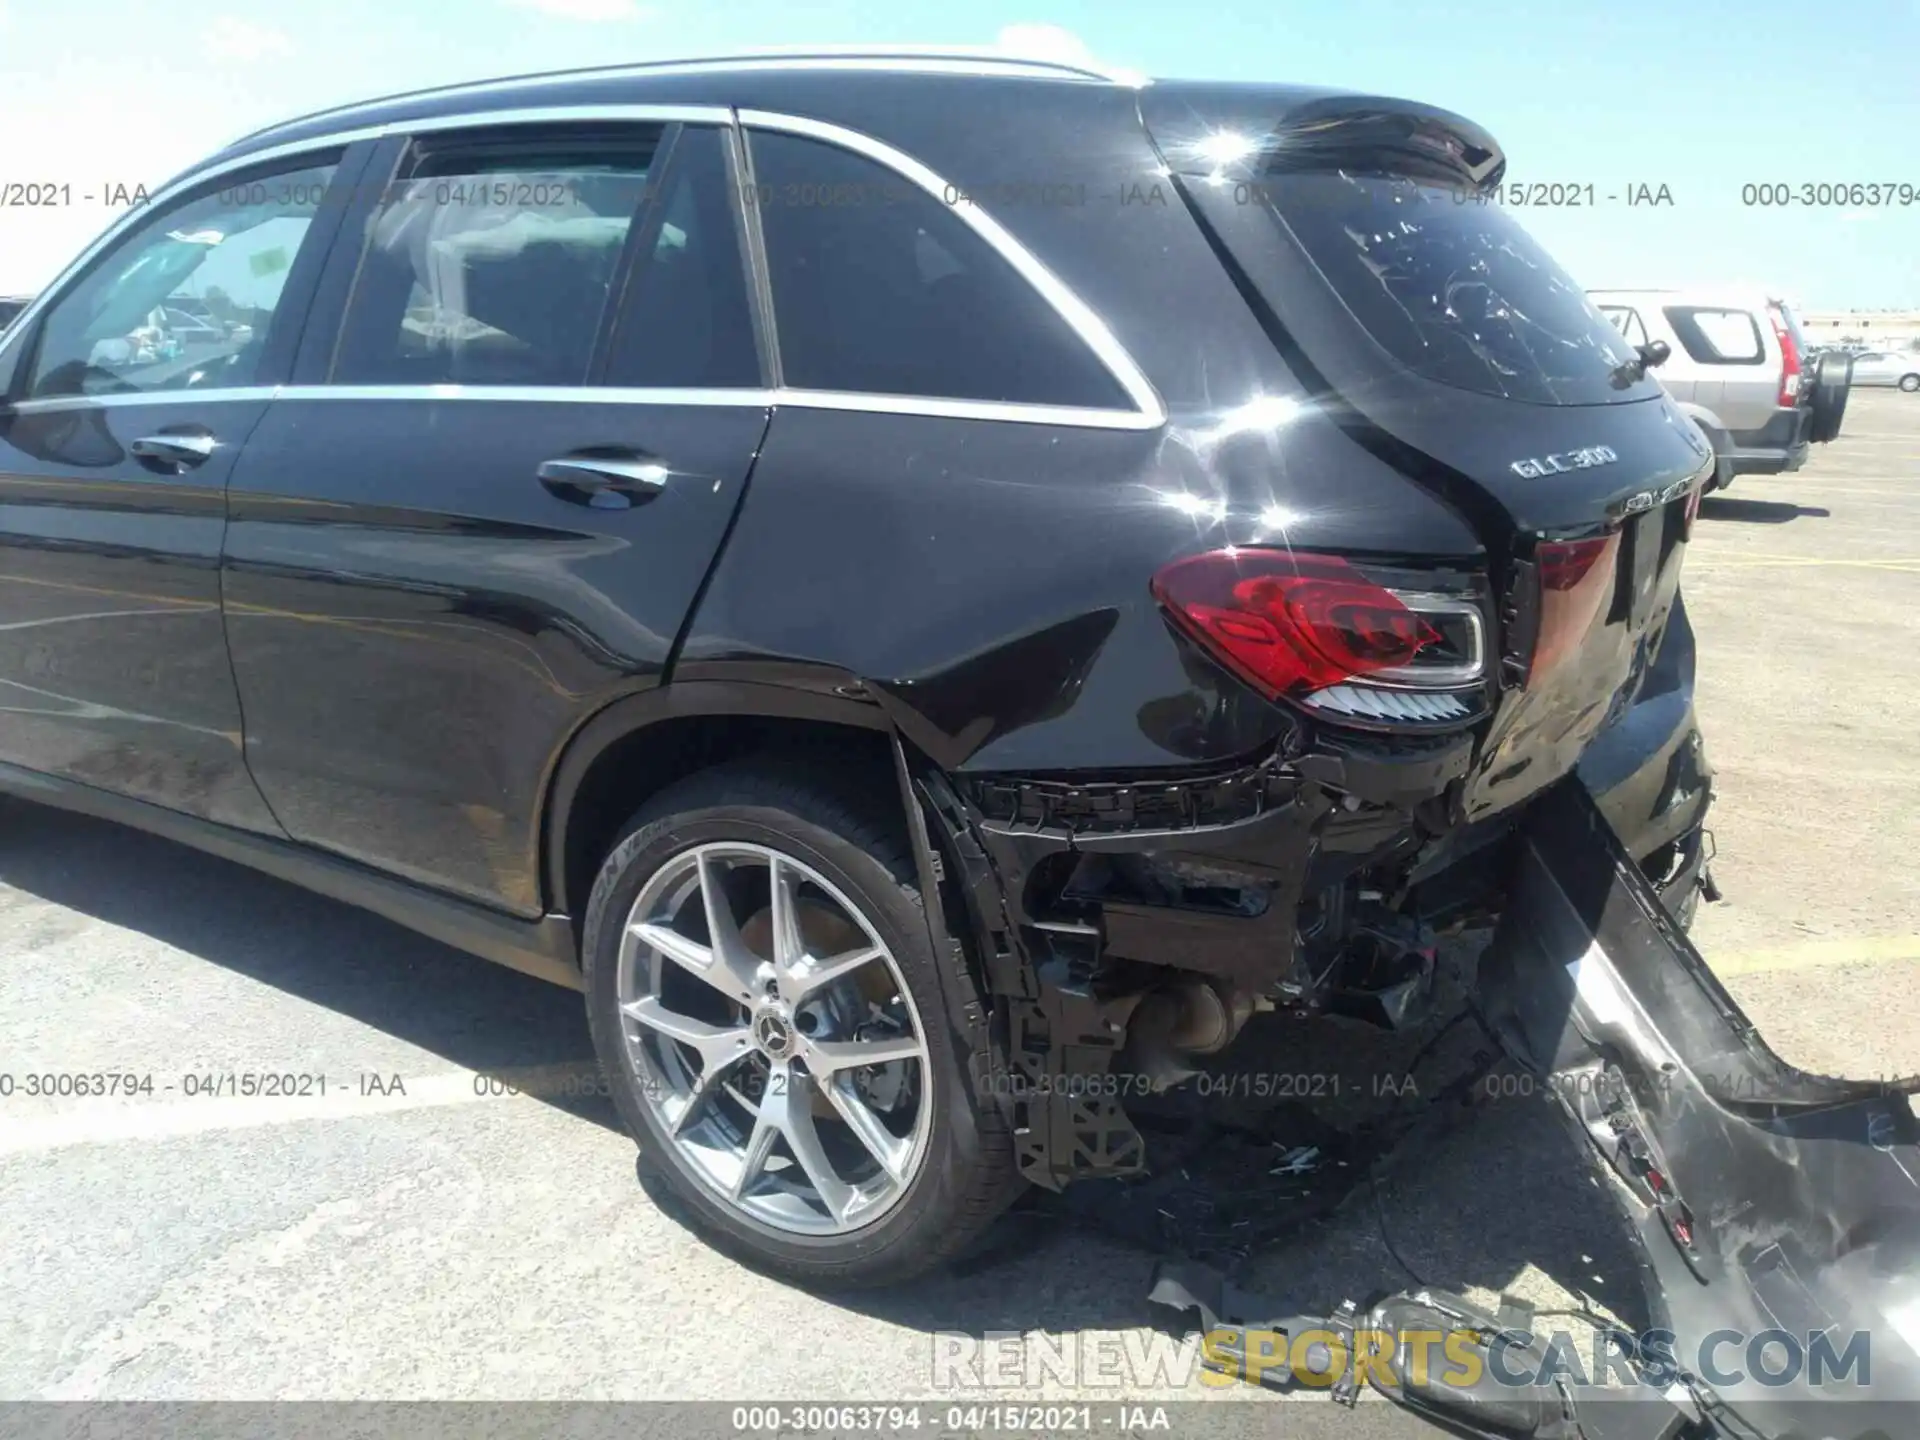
330,131 -> 659,386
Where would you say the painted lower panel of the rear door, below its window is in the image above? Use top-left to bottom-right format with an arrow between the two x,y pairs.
225,399 -> 766,914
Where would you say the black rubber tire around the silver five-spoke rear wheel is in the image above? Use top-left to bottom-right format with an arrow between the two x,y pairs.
582,760 -> 1023,1288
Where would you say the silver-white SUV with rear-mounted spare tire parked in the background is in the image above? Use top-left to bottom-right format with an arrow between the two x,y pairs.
1588,290 -> 1849,490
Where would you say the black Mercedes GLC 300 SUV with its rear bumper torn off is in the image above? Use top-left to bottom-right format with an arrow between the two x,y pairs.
0,54 -> 1713,1283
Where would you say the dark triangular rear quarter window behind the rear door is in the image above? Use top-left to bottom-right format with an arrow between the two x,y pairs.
737,131 -> 1133,409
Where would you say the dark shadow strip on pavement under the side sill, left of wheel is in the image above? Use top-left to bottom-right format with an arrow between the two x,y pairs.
0,801 -> 618,1129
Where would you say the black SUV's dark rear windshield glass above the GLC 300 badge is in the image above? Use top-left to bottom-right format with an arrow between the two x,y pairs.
1250,171 -> 1655,405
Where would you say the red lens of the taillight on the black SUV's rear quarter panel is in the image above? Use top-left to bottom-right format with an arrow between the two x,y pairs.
1154,549 -> 1440,697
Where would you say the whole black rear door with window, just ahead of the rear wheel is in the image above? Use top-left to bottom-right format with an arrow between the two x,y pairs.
223,109 -> 768,914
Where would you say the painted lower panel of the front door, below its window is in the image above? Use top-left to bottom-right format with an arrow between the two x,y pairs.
0,401 -> 278,833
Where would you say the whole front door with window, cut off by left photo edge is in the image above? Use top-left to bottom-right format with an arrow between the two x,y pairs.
0,146 -> 367,833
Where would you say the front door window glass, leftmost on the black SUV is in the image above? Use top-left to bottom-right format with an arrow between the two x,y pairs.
25,163 -> 334,397
